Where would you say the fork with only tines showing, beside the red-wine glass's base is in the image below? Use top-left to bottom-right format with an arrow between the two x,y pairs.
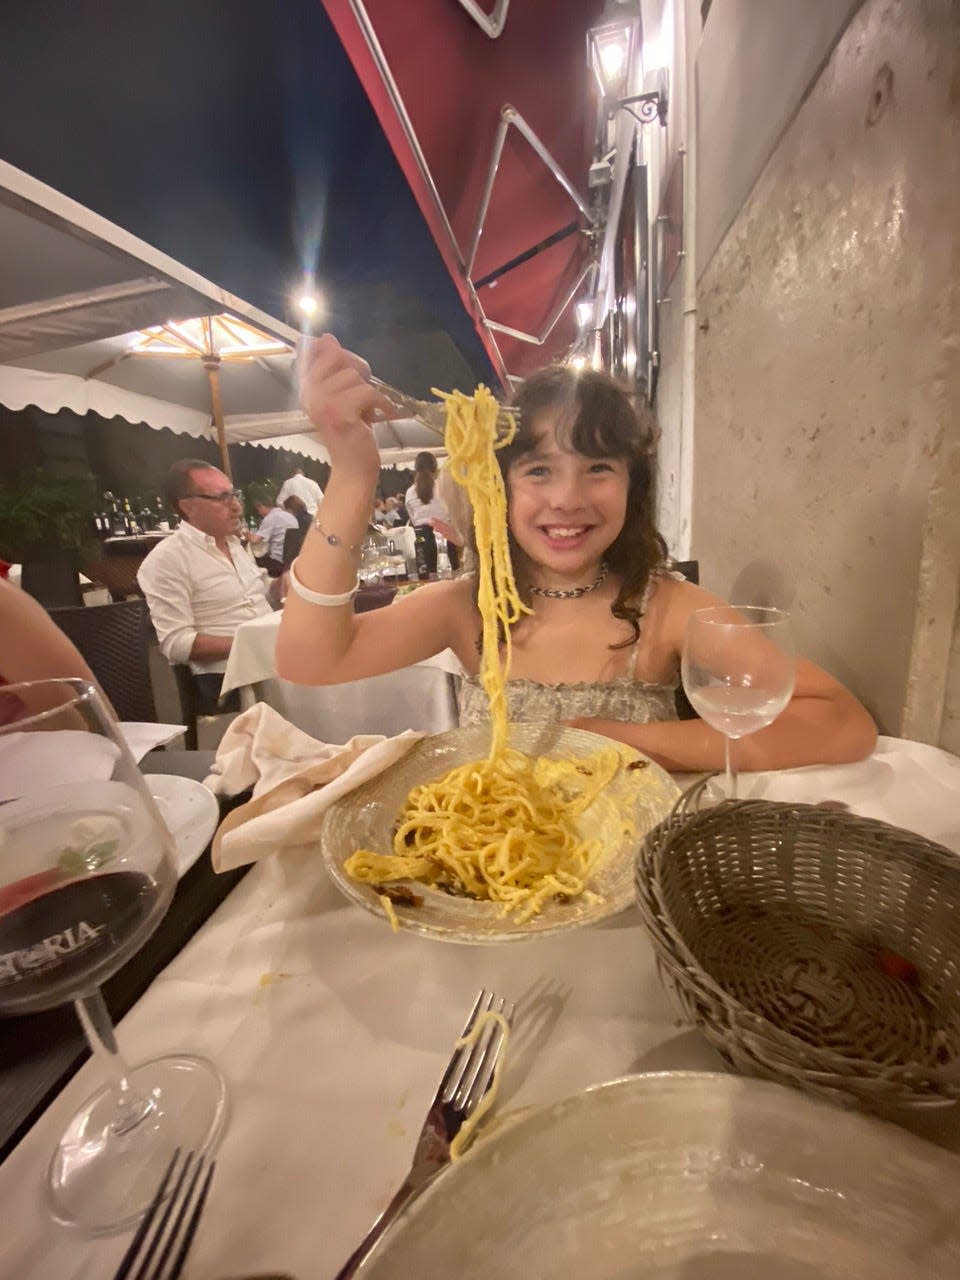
114,1147 -> 216,1280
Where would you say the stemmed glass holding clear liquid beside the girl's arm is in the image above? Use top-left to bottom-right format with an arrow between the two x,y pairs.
681,604 -> 796,800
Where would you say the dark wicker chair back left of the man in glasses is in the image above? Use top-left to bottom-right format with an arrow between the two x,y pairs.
50,599 -> 156,721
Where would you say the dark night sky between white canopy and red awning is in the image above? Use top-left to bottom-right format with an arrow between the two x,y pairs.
0,0 -> 490,394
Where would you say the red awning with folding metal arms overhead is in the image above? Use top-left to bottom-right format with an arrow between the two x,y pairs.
324,0 -> 603,380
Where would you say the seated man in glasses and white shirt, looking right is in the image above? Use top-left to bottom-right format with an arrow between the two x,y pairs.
137,458 -> 280,701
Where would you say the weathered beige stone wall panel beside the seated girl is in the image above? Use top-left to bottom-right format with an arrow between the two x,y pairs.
692,0 -> 960,732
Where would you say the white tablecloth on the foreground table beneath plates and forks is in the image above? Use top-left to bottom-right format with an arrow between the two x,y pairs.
0,739 -> 960,1280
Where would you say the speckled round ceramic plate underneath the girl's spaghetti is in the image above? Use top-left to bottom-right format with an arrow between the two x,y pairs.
320,724 -> 680,942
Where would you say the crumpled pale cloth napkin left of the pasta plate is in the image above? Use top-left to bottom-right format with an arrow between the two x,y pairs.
206,703 -> 424,872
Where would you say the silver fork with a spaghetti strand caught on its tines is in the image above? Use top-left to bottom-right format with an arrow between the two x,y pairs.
334,991 -> 513,1280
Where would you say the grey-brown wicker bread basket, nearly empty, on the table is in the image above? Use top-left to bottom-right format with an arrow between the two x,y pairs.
636,787 -> 960,1108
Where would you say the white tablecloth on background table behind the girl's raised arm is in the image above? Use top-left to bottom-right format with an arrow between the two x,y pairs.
223,613 -> 461,742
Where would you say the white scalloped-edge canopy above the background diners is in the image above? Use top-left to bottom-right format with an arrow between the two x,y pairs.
0,161 -> 439,462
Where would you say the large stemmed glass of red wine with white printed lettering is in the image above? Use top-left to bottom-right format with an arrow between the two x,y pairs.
0,680 -> 225,1234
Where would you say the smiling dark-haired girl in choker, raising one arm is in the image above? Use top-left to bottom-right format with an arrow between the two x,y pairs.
276,335 -> 876,771
